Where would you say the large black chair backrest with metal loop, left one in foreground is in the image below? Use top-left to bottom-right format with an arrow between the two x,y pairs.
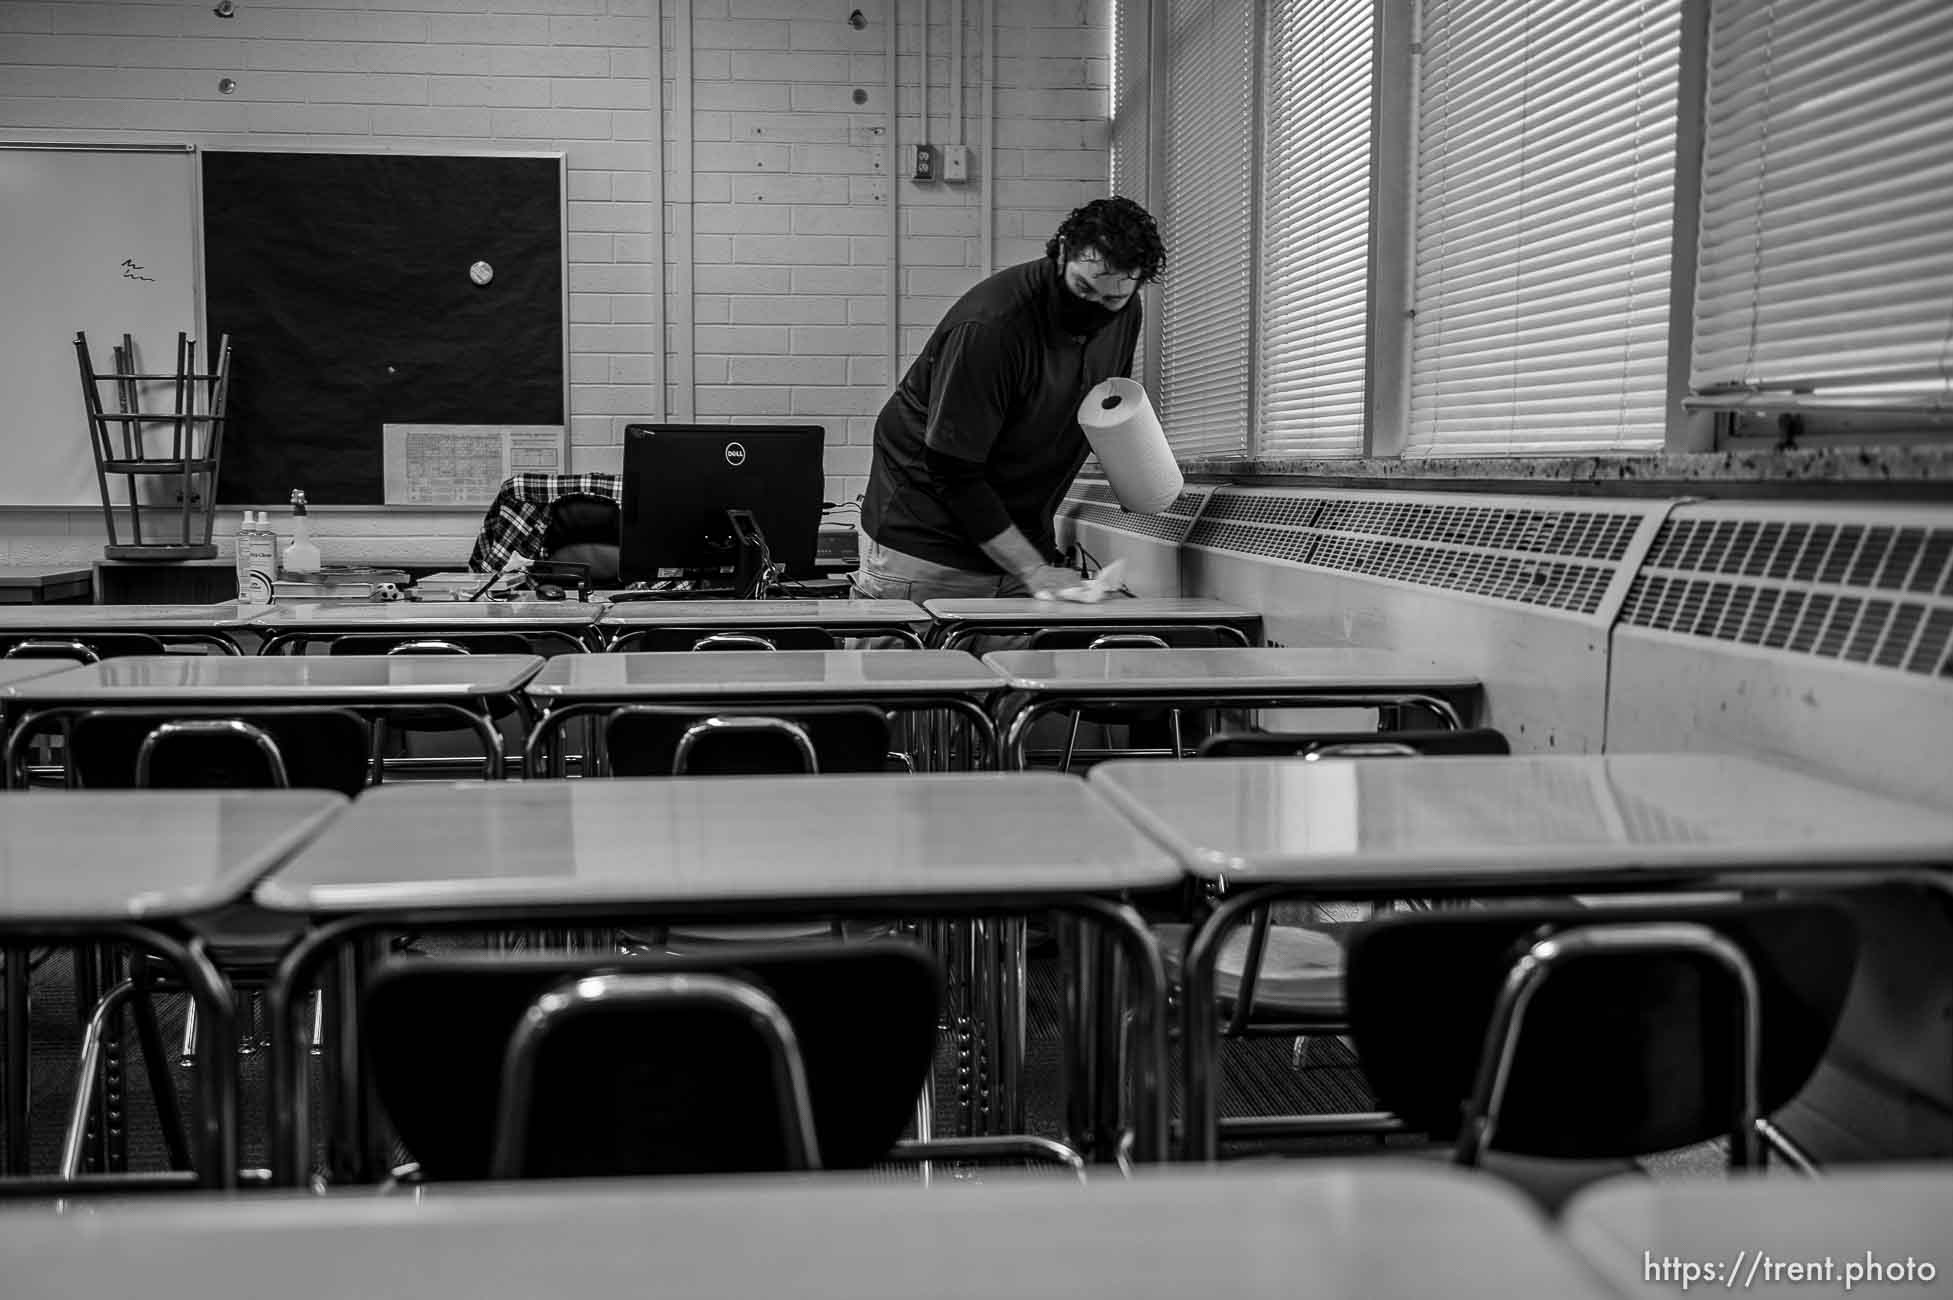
359,943 -> 943,1179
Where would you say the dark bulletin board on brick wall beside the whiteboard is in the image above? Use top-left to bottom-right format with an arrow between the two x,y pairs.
203,150 -> 566,506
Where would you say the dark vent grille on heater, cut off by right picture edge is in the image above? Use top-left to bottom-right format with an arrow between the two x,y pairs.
1621,508 -> 1953,677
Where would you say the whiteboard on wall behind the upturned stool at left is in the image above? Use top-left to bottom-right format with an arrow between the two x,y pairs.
0,141 -> 209,508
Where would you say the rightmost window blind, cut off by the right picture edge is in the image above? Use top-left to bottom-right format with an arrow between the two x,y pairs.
1689,0 -> 1953,408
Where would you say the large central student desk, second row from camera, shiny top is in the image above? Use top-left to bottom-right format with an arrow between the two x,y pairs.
256,772 -> 1180,1185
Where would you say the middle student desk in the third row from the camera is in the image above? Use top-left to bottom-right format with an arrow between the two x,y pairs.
523,650 -> 1004,775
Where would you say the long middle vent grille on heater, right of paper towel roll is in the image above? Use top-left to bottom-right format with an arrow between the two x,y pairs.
1187,488 -> 1648,615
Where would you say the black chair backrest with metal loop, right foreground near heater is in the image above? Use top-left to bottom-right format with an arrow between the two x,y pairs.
1346,898 -> 1857,1159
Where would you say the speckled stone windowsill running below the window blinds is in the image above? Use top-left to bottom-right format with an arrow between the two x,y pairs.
1180,445 -> 1953,500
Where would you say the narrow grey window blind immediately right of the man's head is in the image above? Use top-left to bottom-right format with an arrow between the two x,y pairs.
1154,0 -> 1258,457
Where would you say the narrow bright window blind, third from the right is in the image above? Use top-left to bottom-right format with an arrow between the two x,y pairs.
1256,0 -> 1377,457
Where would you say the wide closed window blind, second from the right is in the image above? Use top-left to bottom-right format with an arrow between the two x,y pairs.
1406,0 -> 1682,455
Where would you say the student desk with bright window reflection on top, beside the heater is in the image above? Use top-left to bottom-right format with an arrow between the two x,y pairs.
1090,753 -> 1953,1159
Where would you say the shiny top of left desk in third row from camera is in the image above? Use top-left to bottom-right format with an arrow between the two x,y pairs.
0,654 -> 543,707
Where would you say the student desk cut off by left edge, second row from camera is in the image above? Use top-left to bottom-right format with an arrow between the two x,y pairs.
0,791 -> 346,1187
